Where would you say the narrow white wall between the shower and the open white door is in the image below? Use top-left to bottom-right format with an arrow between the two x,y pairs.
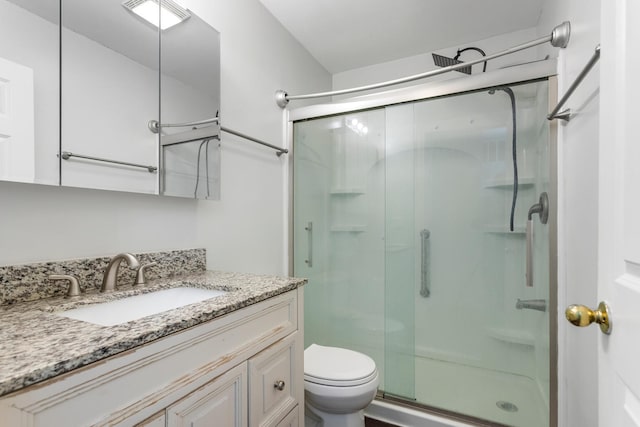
538,0 -> 600,427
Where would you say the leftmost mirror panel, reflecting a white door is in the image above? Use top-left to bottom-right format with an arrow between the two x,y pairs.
0,0 -> 60,185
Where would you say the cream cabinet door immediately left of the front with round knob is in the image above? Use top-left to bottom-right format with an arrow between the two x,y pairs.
167,363 -> 247,427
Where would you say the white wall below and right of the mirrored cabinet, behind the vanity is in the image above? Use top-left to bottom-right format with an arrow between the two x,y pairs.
0,0 -> 331,273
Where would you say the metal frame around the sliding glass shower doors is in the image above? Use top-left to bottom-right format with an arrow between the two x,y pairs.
283,59 -> 559,427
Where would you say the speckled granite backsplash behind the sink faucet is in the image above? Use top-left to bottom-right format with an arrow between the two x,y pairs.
0,249 -> 206,305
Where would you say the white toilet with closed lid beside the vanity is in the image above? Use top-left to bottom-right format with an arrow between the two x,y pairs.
304,344 -> 379,427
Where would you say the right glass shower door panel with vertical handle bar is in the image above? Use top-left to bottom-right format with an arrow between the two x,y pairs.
384,82 -> 550,427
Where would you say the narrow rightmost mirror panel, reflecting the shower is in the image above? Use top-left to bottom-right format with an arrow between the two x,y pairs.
160,7 -> 220,200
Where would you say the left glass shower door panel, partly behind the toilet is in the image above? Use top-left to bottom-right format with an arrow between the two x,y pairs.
292,108 -> 400,392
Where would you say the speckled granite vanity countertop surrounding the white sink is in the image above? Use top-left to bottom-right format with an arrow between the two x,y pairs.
0,271 -> 306,396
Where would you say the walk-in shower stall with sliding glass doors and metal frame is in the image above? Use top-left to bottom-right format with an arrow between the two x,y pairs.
289,61 -> 557,427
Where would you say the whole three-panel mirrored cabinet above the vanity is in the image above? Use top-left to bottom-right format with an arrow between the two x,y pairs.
0,0 -> 220,199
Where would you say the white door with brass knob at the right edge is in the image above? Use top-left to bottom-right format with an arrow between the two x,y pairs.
592,0 -> 640,427
